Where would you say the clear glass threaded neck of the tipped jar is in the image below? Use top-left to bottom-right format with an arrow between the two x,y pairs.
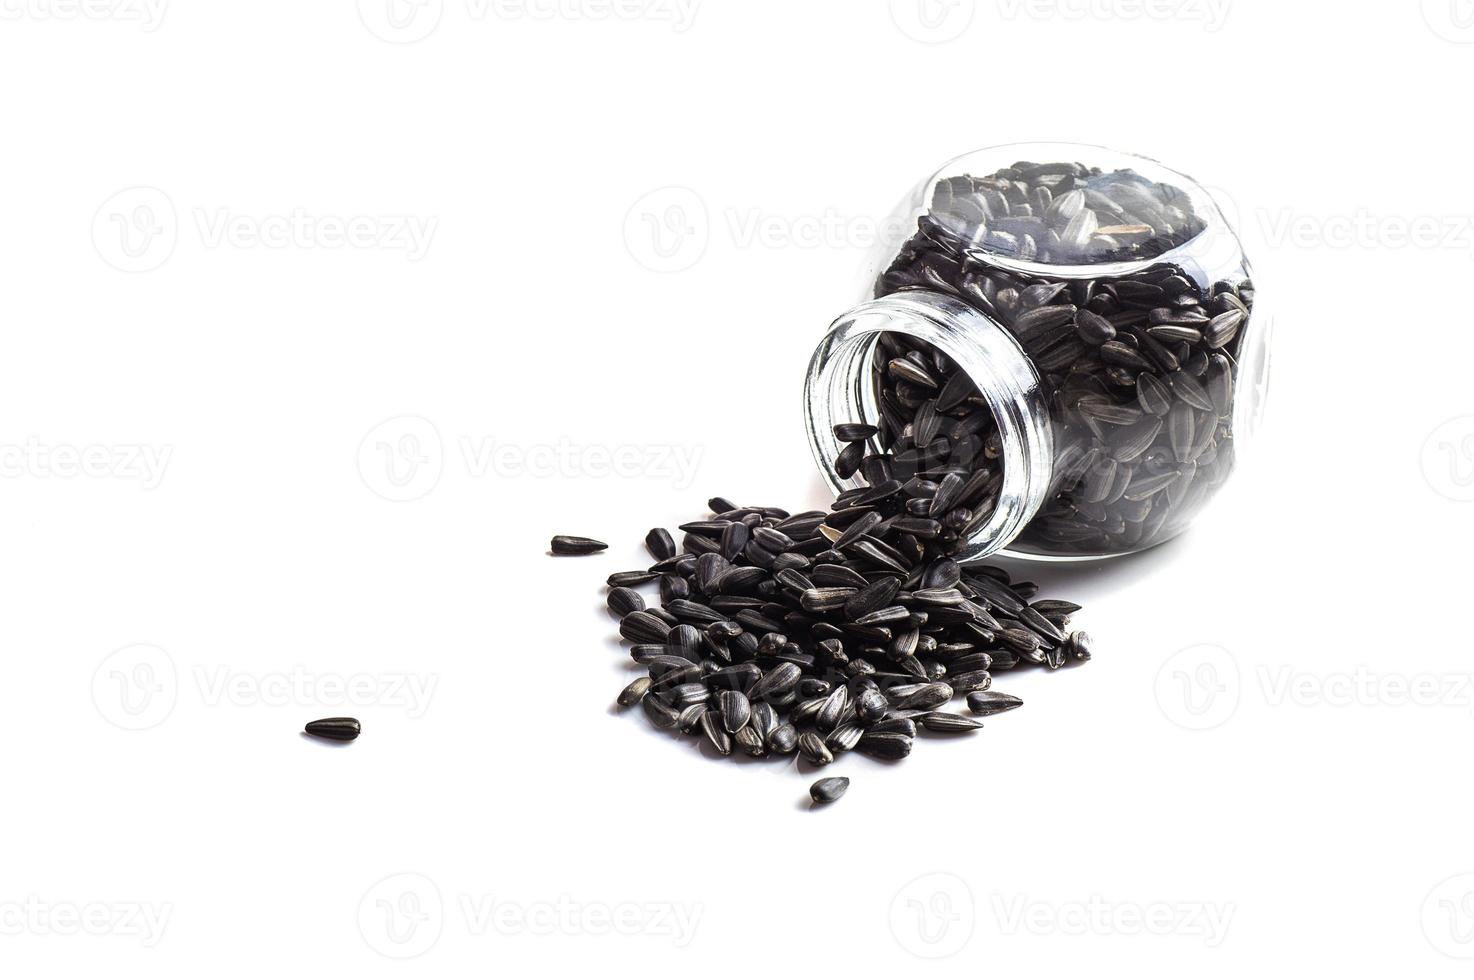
803,289 -> 1054,561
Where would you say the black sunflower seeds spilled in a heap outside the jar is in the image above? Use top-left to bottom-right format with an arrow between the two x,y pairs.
586,462 -> 1091,765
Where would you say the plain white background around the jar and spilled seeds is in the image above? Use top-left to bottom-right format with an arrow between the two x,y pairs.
0,0 -> 1474,977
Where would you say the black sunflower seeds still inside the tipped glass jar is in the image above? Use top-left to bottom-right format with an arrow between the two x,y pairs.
872,161 -> 1254,554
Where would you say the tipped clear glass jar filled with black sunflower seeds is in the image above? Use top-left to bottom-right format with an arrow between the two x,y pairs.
805,143 -> 1269,560
